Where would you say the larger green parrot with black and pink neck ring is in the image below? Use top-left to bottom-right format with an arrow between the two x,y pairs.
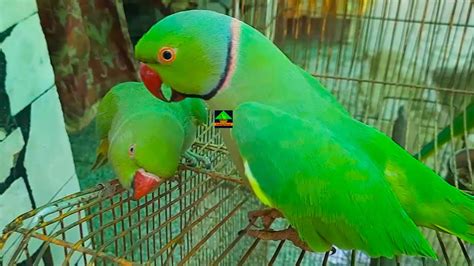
135,10 -> 474,258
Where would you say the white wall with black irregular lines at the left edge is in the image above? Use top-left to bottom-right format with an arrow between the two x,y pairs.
0,0 -> 83,264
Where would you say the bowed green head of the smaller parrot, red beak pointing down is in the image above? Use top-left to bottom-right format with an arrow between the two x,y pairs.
108,112 -> 184,200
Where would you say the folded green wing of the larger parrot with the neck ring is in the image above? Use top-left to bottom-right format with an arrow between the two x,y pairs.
232,103 -> 436,258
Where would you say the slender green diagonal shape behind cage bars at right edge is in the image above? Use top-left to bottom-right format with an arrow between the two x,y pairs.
414,103 -> 474,160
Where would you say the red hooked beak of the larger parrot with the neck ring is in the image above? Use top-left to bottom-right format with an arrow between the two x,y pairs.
140,63 -> 186,102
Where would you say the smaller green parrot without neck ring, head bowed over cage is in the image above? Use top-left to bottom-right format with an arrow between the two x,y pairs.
92,82 -> 210,199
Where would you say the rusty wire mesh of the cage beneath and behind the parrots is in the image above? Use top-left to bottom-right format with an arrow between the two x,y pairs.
0,0 -> 474,265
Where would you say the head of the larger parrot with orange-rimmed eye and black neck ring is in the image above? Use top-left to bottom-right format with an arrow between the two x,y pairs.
135,10 -> 240,101
